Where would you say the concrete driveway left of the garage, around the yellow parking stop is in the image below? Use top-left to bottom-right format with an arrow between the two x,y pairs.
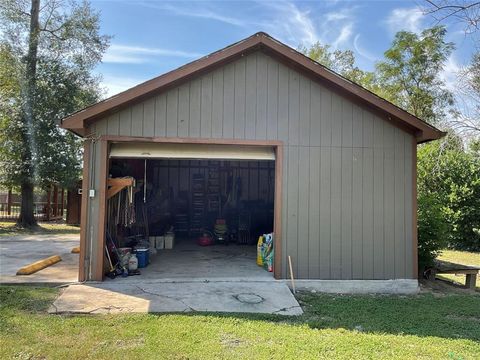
0,234 -> 80,284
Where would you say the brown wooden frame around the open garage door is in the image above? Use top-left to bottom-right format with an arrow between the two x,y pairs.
86,135 -> 283,281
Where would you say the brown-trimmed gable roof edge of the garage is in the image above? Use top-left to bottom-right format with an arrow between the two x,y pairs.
61,32 -> 445,143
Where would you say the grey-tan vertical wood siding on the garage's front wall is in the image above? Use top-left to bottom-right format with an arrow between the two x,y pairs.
90,52 -> 414,279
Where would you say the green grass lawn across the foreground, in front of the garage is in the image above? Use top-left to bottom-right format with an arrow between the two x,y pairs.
0,286 -> 480,359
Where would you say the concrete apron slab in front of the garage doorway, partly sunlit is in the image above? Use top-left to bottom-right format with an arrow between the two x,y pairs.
49,280 -> 303,315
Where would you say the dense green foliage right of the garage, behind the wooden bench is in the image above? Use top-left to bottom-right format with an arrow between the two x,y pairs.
418,135 -> 480,251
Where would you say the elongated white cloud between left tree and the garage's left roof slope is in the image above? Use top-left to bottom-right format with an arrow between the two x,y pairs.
103,44 -> 202,64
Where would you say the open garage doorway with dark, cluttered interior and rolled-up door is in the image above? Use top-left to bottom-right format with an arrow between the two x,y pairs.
106,143 -> 276,281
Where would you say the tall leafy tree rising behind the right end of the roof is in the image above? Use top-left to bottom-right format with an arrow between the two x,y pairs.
376,26 -> 454,124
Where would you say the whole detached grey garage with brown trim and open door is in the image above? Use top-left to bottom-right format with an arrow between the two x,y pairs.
62,33 -> 443,281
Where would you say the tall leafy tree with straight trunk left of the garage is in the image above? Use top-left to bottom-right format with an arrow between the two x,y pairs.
0,0 -> 109,226
